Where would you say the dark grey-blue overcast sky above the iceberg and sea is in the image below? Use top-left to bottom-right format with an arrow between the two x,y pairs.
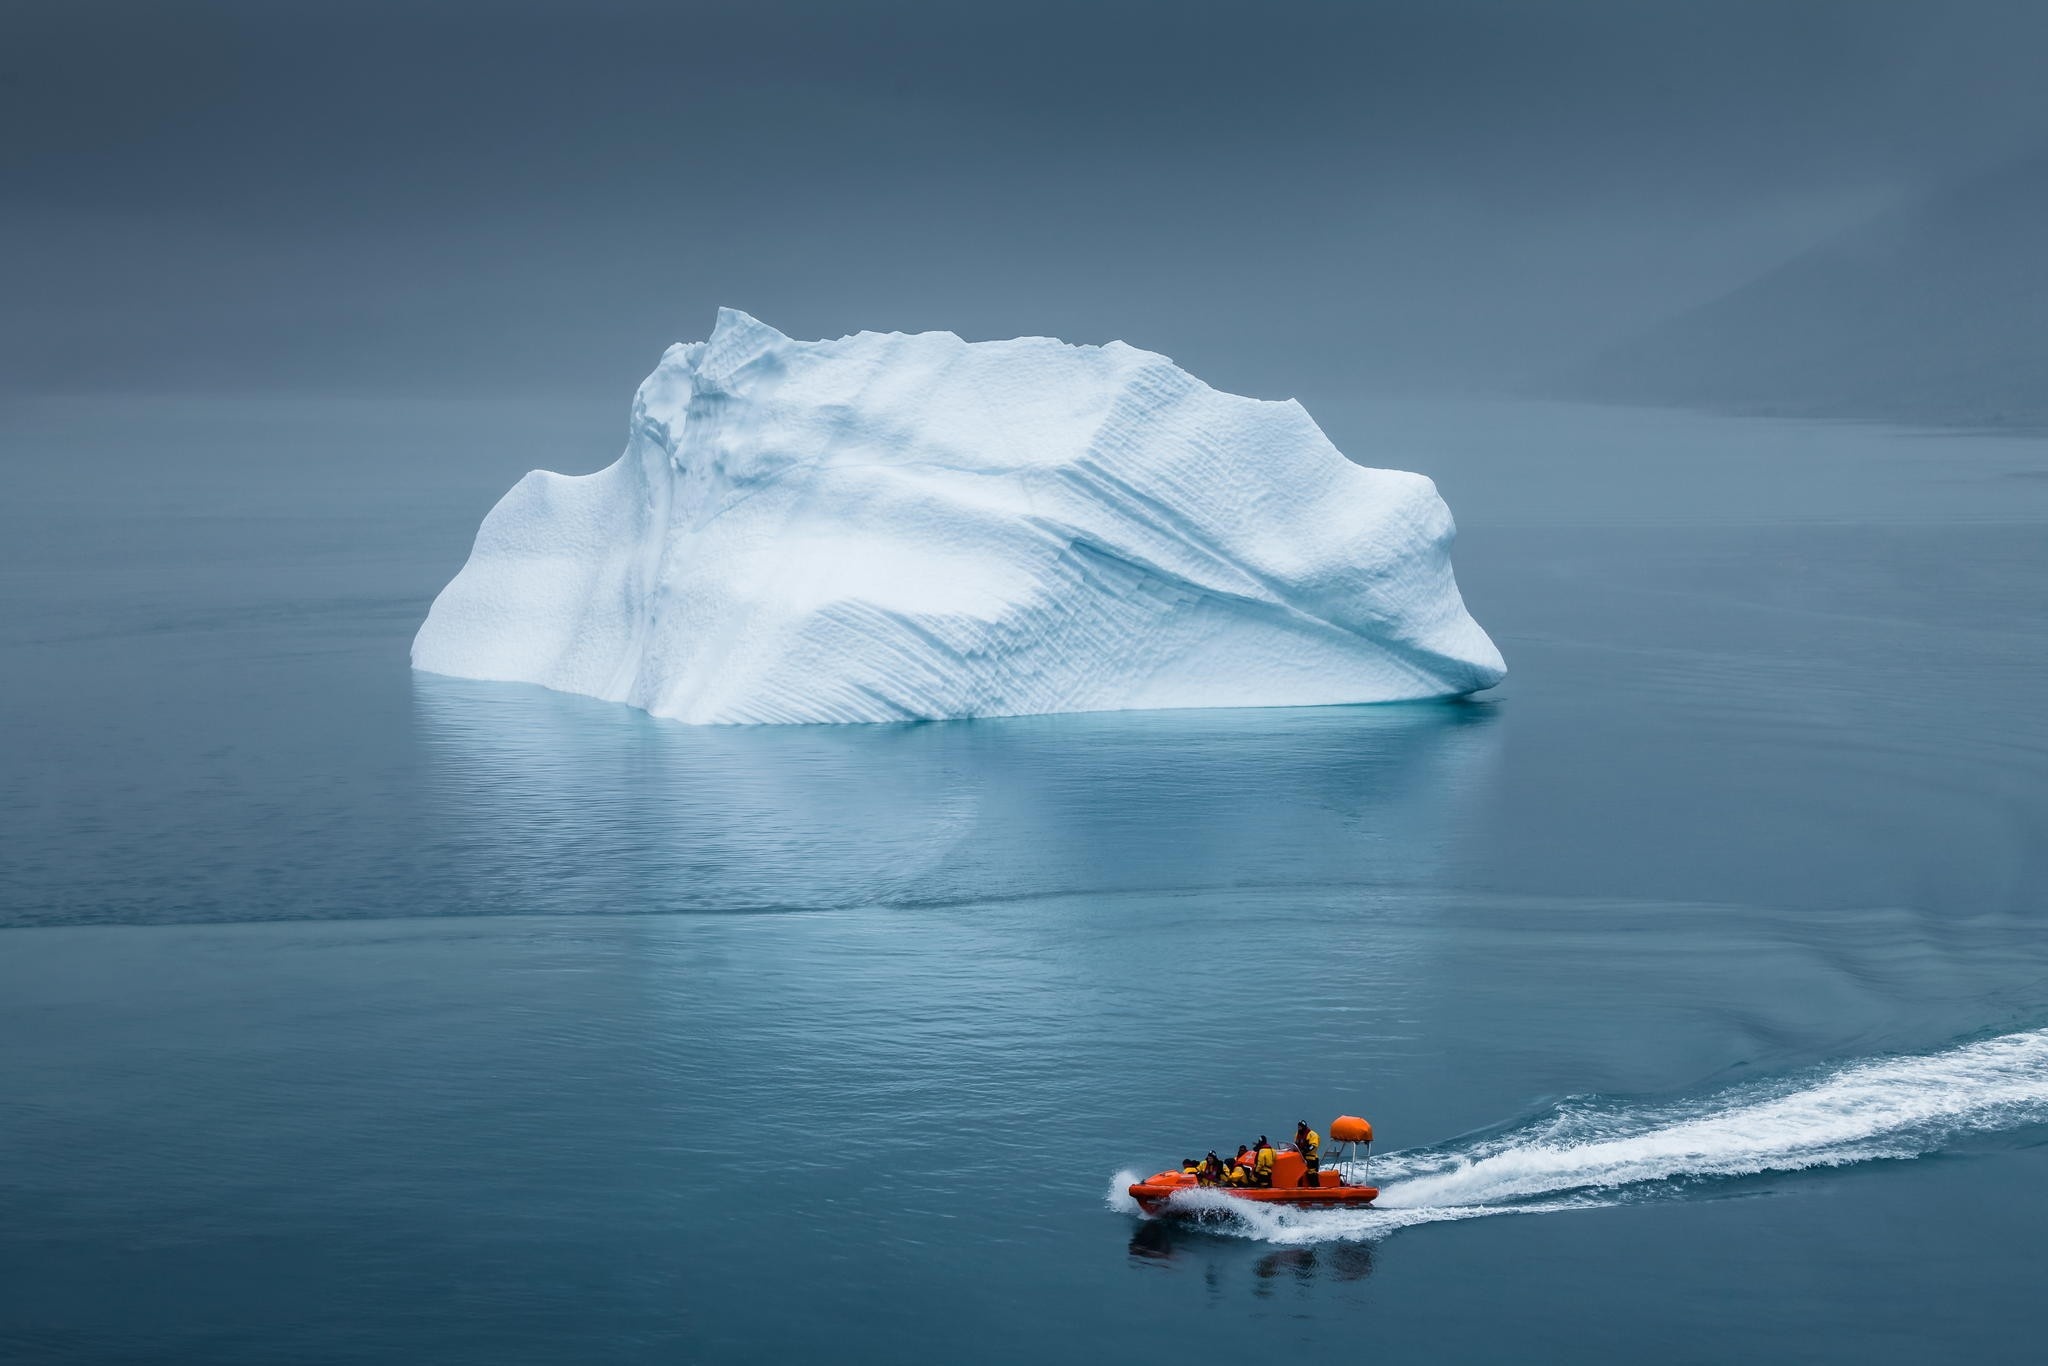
0,0 -> 2048,395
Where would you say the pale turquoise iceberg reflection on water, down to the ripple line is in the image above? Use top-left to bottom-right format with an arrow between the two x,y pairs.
414,674 -> 1497,913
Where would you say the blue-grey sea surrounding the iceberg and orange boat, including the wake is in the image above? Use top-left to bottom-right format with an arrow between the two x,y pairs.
0,389 -> 2048,1362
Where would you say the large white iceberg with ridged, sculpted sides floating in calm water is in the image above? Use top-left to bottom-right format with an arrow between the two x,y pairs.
412,309 -> 1505,723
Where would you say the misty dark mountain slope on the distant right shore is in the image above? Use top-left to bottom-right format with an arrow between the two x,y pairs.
1567,154 -> 2048,426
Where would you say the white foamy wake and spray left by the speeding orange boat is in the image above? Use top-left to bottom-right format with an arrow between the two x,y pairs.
1110,1028 -> 2048,1243
